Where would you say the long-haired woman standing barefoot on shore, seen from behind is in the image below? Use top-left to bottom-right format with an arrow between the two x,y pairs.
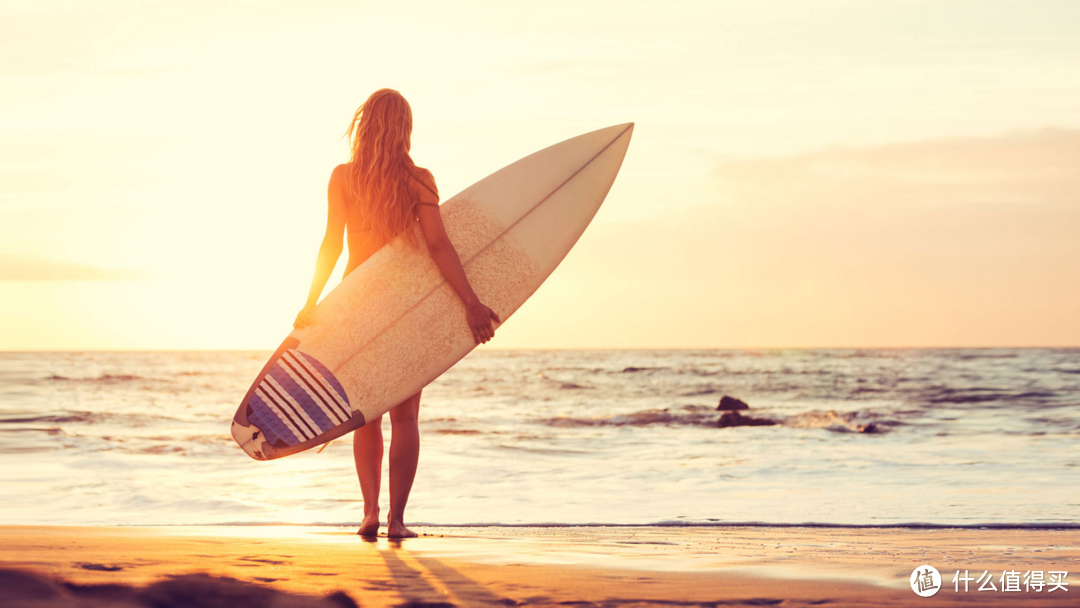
294,89 -> 499,538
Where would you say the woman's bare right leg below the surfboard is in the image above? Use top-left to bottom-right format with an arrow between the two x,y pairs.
387,392 -> 420,538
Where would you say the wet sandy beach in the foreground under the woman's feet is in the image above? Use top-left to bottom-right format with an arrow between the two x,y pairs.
0,526 -> 1080,608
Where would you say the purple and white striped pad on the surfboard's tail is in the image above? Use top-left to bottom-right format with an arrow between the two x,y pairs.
247,349 -> 352,447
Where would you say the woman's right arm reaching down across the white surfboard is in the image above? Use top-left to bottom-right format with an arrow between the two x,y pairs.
417,174 -> 502,344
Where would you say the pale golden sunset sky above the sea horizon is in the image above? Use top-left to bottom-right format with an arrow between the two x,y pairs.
0,0 -> 1080,350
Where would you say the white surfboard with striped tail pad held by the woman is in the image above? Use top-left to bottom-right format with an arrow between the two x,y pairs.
232,123 -> 634,460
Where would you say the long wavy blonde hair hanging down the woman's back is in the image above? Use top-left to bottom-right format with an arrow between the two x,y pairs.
346,89 -> 416,243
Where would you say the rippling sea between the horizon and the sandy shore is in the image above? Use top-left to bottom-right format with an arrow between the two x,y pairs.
0,349 -> 1080,526
